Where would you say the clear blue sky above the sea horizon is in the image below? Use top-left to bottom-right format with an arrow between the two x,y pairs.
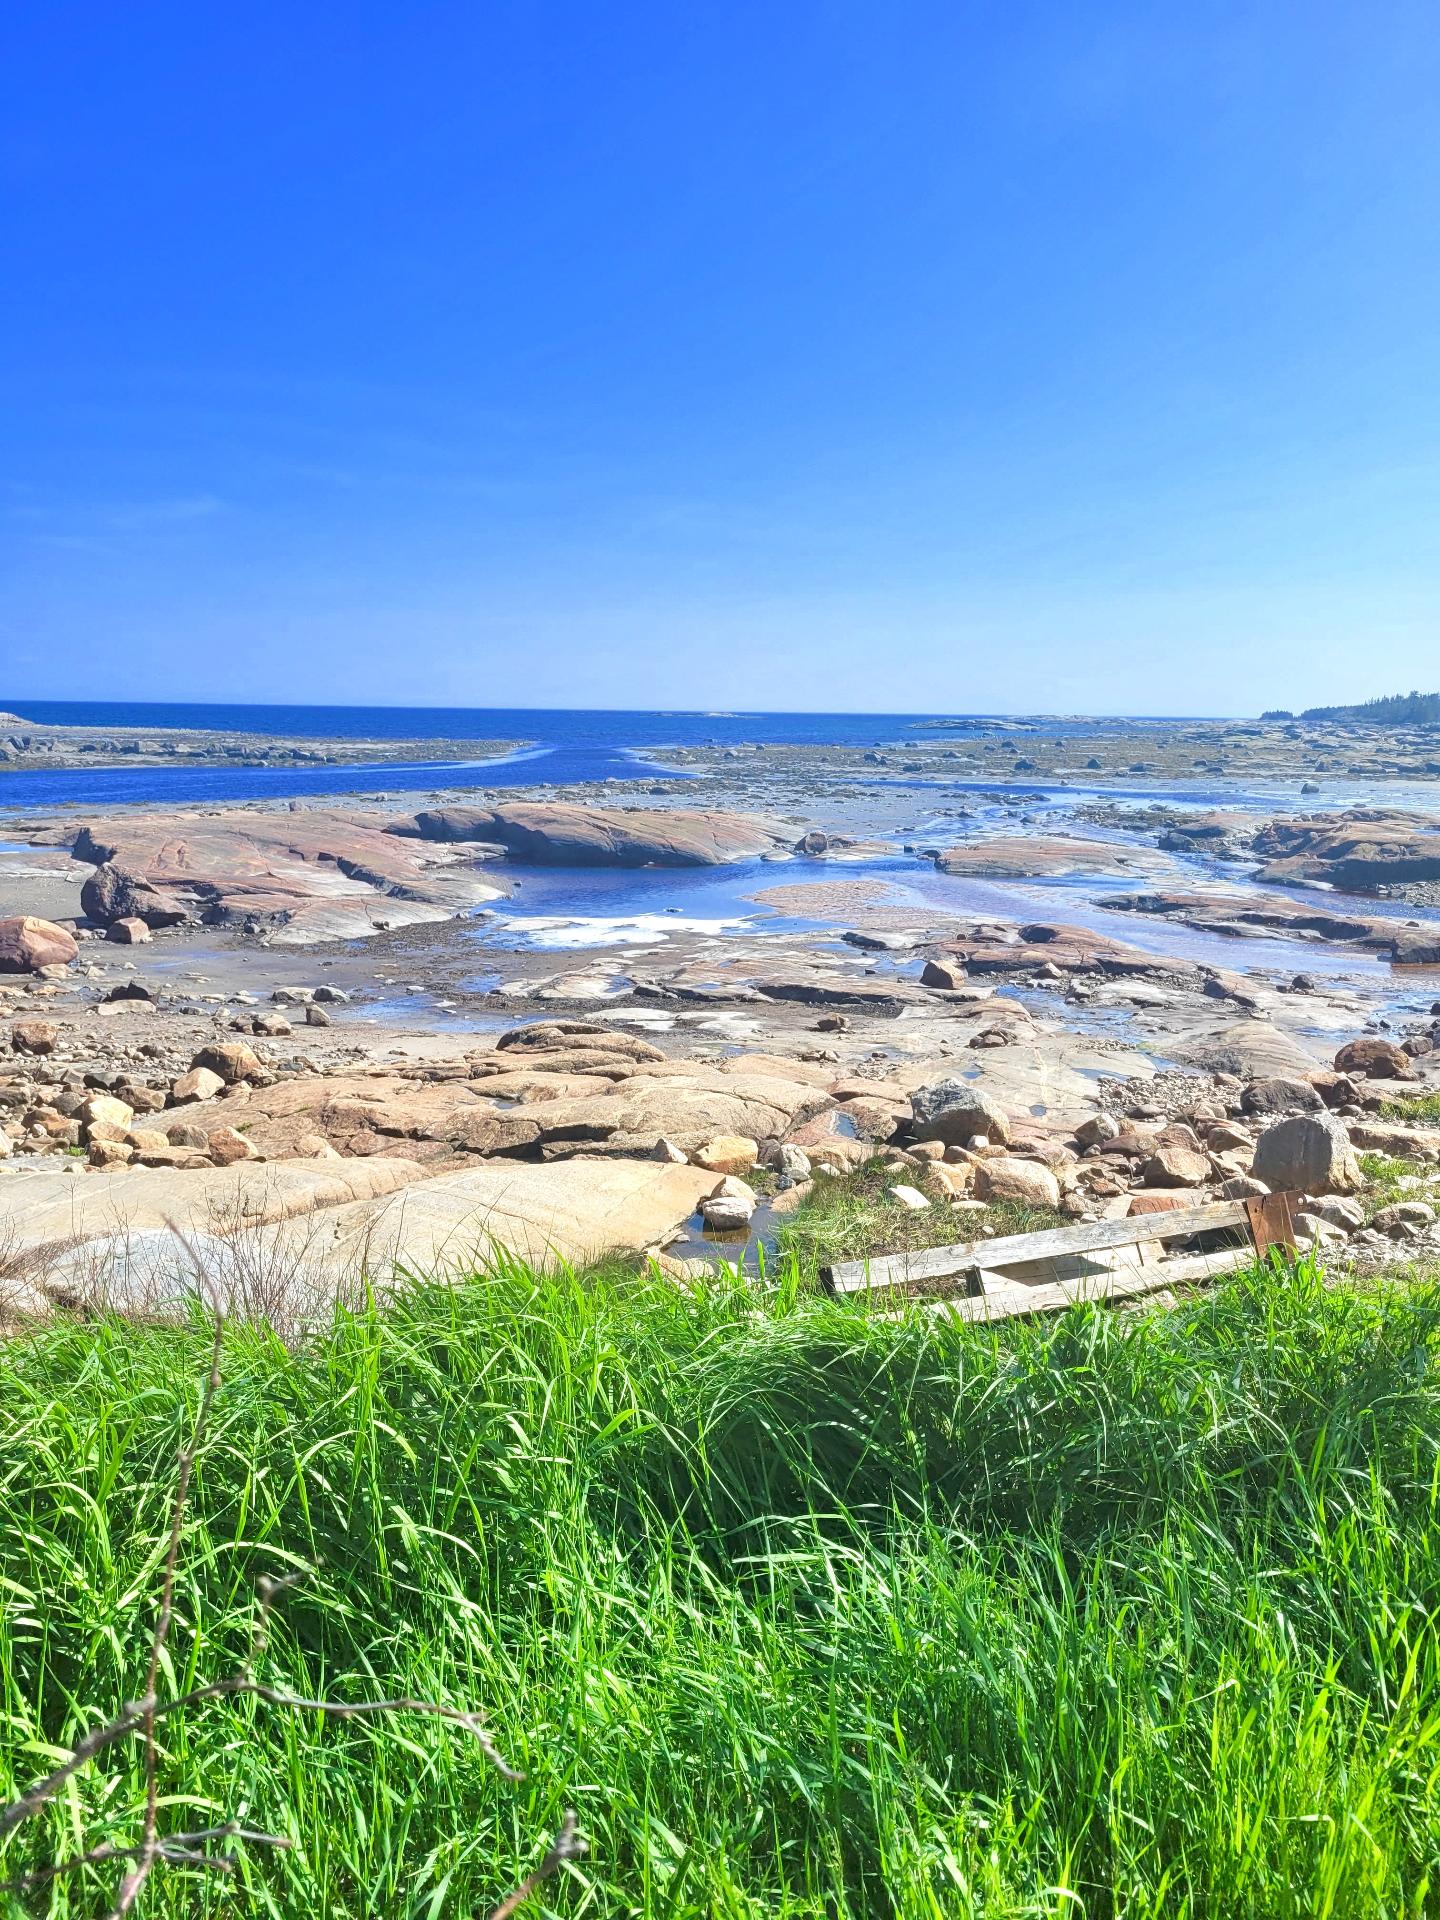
0,0 -> 1440,712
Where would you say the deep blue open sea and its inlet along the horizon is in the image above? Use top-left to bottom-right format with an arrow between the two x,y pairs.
0,699 -> 1159,806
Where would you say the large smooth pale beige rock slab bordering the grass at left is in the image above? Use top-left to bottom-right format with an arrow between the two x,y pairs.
0,1158 -> 714,1327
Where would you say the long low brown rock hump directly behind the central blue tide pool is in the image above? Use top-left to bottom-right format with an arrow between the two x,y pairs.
392,803 -> 787,866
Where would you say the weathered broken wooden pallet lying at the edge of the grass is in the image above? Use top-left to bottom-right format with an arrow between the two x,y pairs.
820,1194 -> 1294,1321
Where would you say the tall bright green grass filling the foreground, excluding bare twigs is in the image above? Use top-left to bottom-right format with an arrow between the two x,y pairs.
0,1265 -> 1440,1920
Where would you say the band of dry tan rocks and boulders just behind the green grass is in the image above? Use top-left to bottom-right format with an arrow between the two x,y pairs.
11,1021 -> 1440,1321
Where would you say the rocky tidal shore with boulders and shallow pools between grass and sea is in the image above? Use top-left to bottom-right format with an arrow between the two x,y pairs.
0,774 -> 1440,1311
